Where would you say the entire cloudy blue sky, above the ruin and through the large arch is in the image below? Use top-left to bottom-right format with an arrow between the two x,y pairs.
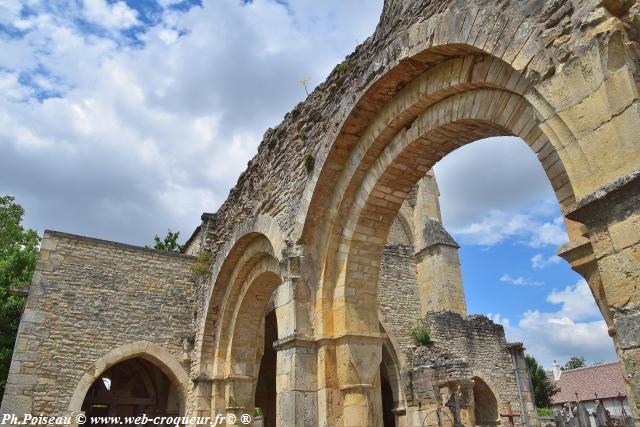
0,0 -> 615,367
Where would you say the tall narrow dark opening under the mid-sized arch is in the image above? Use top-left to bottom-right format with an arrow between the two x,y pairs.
255,304 -> 278,427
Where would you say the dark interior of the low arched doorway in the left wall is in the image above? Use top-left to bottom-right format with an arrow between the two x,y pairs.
82,357 -> 180,419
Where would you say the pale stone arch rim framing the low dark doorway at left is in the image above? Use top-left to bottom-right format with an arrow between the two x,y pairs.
68,341 -> 190,420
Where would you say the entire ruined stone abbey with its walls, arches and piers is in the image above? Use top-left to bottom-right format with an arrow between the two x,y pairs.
0,0 -> 640,426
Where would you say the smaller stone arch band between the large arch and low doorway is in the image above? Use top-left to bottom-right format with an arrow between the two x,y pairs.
194,215 -> 287,378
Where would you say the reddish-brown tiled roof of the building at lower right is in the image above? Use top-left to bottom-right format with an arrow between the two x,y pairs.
549,363 -> 627,404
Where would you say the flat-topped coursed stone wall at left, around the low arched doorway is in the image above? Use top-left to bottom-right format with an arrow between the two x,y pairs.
0,231 -> 194,415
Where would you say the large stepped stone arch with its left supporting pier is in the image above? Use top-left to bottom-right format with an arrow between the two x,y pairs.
298,8 -> 636,424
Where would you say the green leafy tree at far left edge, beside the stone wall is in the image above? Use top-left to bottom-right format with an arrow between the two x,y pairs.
0,196 -> 40,398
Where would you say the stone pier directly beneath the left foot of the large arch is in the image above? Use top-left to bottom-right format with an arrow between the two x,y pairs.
336,335 -> 382,427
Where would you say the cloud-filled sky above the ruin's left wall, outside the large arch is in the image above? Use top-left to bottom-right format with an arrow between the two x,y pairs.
0,0 -> 382,244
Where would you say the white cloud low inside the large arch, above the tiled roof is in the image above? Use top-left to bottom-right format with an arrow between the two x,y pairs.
490,280 -> 615,367
